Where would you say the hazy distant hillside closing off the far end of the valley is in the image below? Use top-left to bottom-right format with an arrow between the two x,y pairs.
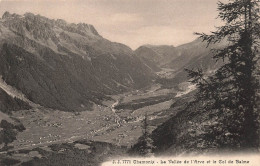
135,39 -> 226,87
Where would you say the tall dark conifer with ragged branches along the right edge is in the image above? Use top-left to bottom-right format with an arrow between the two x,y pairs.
187,0 -> 260,150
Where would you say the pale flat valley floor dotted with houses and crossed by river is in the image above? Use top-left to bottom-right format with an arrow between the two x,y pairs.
10,85 -> 176,150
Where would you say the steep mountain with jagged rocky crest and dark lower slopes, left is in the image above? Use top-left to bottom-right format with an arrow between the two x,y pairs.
0,12 -> 153,111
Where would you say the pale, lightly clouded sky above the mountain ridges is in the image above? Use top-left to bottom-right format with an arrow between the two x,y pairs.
0,0 -> 221,49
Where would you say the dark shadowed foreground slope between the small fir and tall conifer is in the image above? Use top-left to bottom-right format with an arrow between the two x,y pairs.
129,91 -> 232,156
